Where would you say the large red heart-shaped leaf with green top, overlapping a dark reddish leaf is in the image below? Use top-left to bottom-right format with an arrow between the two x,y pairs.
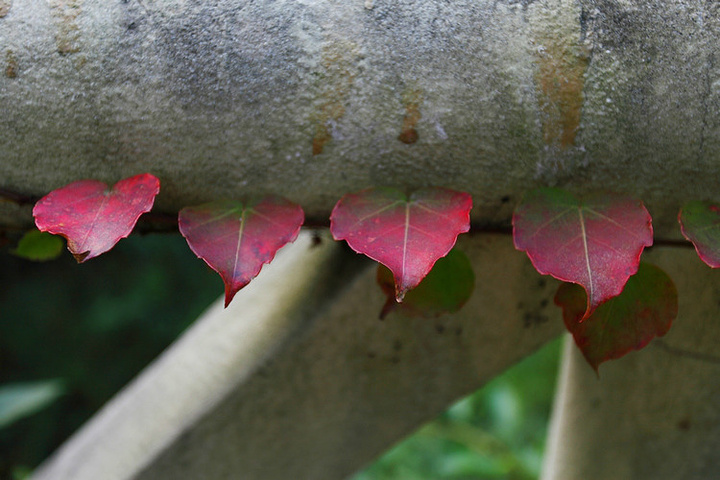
513,188 -> 653,318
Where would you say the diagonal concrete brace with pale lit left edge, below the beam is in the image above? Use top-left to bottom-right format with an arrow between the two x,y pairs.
33,234 -> 562,480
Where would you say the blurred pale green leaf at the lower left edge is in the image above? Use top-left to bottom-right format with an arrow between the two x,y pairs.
0,380 -> 64,428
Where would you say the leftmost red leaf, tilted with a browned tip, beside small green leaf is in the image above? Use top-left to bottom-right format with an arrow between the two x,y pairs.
33,173 -> 160,263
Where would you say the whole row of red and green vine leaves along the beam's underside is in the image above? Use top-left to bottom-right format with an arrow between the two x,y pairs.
2,173 -> 720,371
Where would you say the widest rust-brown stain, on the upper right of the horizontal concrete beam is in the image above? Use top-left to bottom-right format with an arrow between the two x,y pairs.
535,38 -> 589,149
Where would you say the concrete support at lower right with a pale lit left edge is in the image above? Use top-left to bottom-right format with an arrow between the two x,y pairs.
542,249 -> 720,480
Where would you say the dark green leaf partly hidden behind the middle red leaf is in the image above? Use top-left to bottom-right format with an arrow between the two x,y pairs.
377,248 -> 475,319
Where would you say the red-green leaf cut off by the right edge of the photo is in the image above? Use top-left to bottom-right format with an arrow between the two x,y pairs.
678,202 -> 720,268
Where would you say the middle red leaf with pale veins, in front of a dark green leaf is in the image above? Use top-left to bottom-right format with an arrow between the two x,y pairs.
330,187 -> 472,302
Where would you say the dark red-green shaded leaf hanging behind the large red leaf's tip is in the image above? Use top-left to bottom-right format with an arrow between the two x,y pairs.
555,263 -> 678,372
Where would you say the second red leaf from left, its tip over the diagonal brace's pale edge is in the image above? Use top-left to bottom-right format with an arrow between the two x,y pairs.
178,195 -> 305,307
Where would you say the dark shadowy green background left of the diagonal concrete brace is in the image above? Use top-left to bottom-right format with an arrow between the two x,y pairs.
0,235 -> 223,479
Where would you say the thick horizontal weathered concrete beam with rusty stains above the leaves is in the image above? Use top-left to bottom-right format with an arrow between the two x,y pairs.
0,0 -> 720,237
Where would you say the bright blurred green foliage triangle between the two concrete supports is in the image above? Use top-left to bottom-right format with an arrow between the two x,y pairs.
353,339 -> 560,480
